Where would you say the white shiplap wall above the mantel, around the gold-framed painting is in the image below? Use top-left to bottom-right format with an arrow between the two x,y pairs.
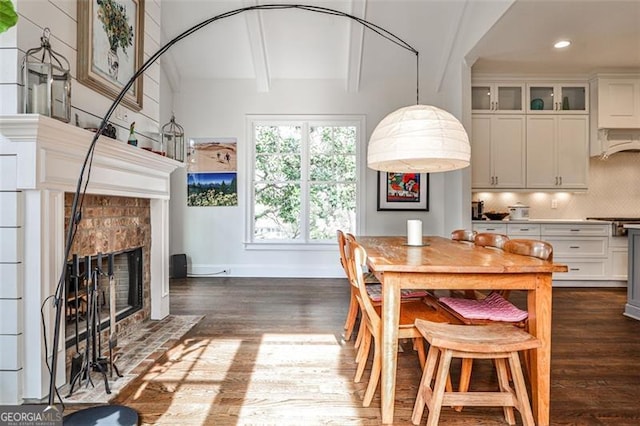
0,0 -> 161,146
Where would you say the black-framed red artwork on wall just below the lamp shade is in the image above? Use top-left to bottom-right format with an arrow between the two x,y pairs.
378,172 -> 429,211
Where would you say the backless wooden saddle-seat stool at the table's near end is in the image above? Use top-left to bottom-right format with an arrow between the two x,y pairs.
411,319 -> 541,426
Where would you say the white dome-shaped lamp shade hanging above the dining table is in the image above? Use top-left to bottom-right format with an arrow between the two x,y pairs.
367,105 -> 471,173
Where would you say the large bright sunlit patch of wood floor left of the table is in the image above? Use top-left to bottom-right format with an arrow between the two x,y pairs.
133,334 -> 362,426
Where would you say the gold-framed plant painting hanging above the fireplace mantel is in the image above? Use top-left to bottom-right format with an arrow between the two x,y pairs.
77,0 -> 144,111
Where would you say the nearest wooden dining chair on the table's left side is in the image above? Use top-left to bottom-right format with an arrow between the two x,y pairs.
346,235 -> 459,407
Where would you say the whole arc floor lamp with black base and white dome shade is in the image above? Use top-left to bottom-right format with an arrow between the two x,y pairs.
48,4 -> 471,425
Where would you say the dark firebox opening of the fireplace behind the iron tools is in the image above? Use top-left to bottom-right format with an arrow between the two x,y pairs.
65,247 -> 143,349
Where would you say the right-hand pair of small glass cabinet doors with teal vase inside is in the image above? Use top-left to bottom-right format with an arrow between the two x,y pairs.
527,82 -> 589,114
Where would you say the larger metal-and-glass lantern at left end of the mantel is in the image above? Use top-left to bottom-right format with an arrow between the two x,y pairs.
22,28 -> 71,123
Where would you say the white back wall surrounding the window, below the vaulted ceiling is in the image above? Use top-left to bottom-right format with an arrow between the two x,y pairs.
170,76 -> 468,276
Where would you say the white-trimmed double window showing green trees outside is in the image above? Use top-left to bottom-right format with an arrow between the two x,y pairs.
249,116 -> 364,243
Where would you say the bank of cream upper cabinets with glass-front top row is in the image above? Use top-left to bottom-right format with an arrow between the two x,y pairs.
471,76 -> 590,191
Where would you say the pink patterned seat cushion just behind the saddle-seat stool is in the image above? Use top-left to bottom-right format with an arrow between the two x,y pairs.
439,292 -> 529,322
